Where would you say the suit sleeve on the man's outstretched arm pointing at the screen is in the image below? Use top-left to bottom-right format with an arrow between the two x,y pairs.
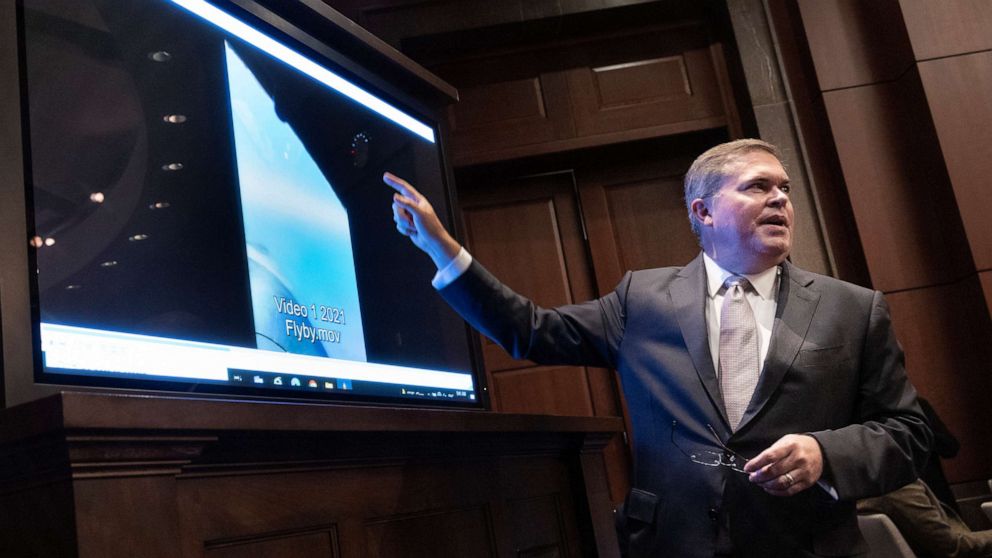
438,261 -> 630,367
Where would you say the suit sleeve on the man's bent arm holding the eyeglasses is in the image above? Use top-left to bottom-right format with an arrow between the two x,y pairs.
811,291 -> 932,500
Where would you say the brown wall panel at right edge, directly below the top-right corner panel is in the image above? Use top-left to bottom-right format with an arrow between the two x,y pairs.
919,51 -> 992,270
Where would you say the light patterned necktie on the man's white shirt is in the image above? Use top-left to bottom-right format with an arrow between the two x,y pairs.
720,275 -> 761,430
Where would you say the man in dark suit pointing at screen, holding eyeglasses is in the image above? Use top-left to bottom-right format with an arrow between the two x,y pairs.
384,140 -> 931,558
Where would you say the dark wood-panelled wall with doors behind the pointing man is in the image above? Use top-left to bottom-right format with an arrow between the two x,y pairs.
325,0 -> 992,510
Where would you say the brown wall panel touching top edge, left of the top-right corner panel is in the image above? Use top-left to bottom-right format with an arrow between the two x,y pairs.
799,0 -> 913,91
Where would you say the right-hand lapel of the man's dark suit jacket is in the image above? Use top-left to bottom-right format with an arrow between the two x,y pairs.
737,262 -> 820,430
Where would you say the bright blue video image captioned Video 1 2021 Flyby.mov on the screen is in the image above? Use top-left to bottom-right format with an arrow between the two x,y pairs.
224,44 -> 366,360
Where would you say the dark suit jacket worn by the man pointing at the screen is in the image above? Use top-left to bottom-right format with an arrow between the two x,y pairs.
441,255 -> 931,558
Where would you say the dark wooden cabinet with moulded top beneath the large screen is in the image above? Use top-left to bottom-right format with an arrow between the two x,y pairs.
0,392 -> 622,558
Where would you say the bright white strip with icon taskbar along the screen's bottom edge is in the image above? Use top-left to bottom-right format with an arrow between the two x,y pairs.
40,323 -> 476,405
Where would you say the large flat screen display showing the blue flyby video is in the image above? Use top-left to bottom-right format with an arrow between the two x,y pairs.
20,0 -> 477,405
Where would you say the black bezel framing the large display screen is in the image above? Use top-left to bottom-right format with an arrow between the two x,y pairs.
0,0 -> 488,410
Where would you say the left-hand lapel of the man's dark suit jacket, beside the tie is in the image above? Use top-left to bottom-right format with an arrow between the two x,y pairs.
669,253 -> 728,423
